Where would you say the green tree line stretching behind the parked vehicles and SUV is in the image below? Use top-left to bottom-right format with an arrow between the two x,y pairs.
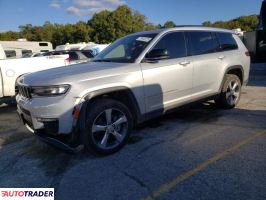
0,5 -> 258,47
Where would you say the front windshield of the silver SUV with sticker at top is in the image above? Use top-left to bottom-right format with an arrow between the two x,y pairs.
93,33 -> 157,63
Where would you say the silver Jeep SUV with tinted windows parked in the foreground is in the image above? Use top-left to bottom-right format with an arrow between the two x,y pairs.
16,26 -> 250,154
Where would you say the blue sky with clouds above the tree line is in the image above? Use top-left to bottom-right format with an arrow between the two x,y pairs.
0,0 -> 262,32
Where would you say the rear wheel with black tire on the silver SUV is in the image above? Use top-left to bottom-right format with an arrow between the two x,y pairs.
215,74 -> 241,109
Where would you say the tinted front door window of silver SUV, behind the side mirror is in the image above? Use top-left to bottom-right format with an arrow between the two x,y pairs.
153,32 -> 187,59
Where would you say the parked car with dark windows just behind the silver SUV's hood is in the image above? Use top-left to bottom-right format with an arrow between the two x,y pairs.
42,50 -> 94,64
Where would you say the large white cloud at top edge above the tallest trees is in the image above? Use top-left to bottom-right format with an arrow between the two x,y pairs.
67,0 -> 126,16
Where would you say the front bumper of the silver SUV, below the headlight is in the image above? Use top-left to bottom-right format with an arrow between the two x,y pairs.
16,95 -> 75,135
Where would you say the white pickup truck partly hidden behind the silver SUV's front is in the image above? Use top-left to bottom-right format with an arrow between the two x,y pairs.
0,55 -> 69,103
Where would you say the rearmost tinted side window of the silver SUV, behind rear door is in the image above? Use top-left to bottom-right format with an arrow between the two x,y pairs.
217,33 -> 238,51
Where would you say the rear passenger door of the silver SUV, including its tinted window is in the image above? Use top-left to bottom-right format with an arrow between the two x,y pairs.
186,31 -> 224,98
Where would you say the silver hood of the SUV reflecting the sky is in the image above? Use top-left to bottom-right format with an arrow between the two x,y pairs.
21,62 -> 128,86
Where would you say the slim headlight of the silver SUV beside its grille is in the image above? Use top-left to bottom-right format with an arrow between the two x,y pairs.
31,85 -> 70,97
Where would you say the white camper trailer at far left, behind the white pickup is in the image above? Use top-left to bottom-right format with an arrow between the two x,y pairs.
0,39 -> 53,58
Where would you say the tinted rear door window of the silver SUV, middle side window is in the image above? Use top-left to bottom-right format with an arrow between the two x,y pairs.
188,31 -> 217,55
